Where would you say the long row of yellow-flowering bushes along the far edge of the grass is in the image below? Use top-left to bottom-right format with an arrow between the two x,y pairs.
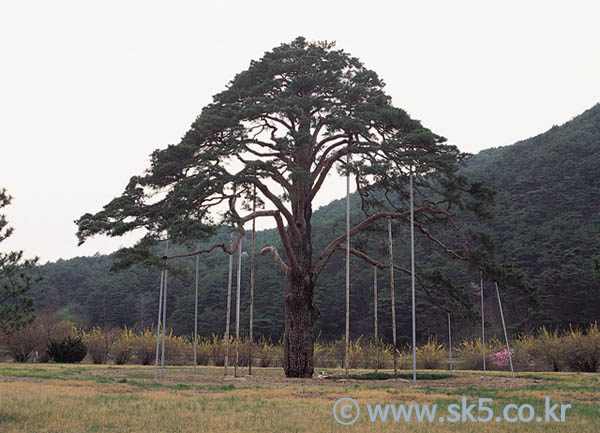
0,313 -> 600,372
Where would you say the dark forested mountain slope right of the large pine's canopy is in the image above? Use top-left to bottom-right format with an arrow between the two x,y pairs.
464,104 -> 600,325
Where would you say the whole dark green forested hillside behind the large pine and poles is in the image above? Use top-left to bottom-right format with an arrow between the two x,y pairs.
32,104 -> 600,342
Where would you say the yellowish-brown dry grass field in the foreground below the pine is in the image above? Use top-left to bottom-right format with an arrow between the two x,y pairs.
0,364 -> 600,433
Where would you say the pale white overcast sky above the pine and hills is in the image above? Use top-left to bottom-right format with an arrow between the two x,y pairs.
0,0 -> 600,261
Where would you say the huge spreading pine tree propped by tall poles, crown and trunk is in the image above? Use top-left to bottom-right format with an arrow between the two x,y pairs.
77,38 -> 492,377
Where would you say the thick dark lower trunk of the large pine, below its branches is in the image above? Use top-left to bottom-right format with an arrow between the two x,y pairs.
283,275 -> 318,377
